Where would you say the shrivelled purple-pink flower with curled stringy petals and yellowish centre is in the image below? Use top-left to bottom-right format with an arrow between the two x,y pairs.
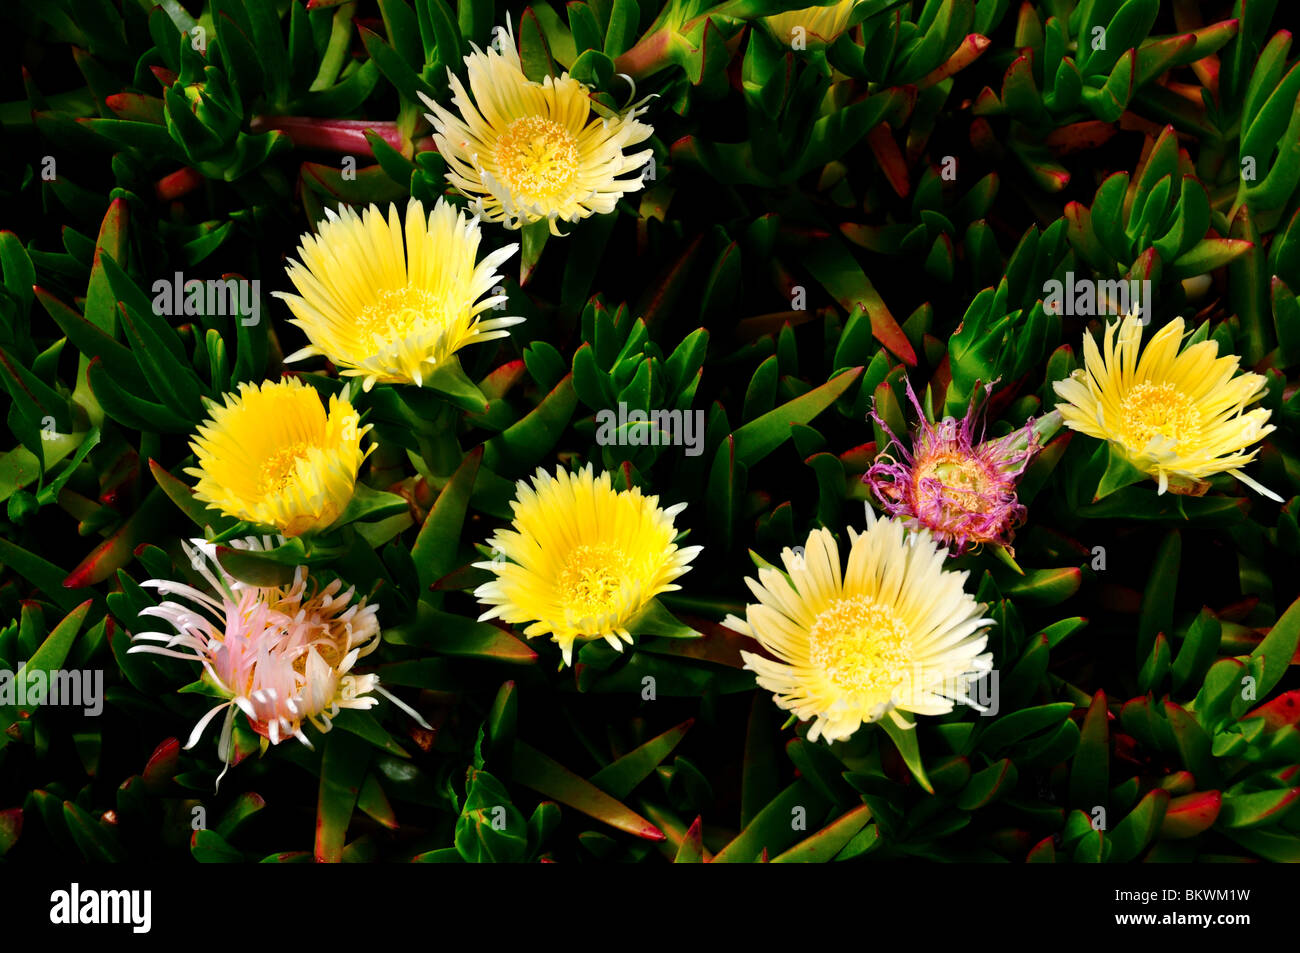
862,381 -> 1056,556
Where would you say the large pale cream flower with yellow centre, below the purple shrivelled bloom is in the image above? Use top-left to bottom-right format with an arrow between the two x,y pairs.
724,510 -> 993,741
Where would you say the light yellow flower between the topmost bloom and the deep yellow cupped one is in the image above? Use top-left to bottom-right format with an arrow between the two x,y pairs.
274,199 -> 524,390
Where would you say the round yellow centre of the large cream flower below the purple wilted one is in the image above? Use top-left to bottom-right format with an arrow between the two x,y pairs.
809,595 -> 911,702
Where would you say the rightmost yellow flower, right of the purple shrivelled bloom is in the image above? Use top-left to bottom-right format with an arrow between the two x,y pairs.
1052,315 -> 1282,503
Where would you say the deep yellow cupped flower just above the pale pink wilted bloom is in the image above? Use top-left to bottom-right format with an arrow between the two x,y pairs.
186,378 -> 374,536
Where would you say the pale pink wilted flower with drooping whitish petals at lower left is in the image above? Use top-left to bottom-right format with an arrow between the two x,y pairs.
129,537 -> 429,780
